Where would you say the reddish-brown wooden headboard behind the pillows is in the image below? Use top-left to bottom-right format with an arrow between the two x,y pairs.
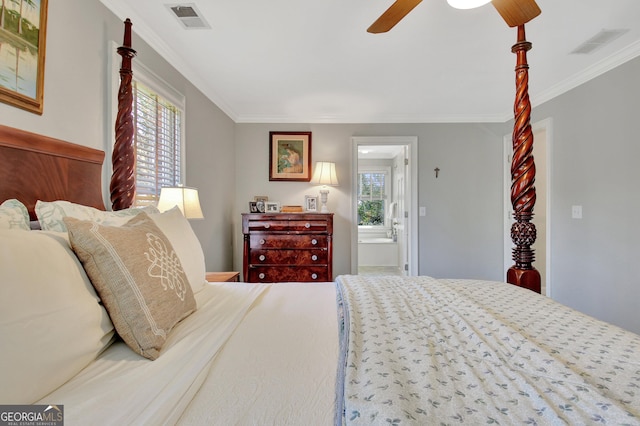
0,125 -> 105,220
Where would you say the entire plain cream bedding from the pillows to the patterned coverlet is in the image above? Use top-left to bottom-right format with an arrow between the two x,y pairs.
39,283 -> 338,426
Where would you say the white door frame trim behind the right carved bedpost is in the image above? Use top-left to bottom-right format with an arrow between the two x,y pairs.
503,117 -> 553,297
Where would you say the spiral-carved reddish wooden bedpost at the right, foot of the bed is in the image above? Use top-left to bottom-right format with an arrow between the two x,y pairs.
507,25 -> 540,293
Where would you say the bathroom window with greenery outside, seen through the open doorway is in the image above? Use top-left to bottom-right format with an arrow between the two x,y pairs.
358,169 -> 389,227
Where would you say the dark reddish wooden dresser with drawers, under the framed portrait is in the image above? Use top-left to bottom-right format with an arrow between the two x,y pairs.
242,213 -> 333,283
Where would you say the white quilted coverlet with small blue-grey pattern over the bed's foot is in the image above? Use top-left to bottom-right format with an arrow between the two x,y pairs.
336,276 -> 640,425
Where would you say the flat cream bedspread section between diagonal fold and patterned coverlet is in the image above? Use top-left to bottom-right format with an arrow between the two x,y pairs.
180,283 -> 338,426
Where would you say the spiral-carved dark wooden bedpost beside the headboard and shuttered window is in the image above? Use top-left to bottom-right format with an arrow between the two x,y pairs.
110,18 -> 136,210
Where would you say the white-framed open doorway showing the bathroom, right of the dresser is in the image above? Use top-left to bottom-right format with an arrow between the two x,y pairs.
351,136 -> 418,275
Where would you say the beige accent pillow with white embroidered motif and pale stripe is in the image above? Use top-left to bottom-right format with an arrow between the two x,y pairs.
64,213 -> 196,359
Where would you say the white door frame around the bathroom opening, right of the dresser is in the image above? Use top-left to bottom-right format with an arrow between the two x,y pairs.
351,136 -> 418,275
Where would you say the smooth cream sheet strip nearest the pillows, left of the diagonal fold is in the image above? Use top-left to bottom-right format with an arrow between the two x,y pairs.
39,283 -> 269,426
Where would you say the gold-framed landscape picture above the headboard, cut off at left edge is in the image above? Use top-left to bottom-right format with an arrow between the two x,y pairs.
0,0 -> 48,114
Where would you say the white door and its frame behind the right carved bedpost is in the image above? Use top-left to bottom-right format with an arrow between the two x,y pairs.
504,118 -> 553,297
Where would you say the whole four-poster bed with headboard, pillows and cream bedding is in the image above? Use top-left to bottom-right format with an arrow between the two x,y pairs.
0,17 -> 640,425
